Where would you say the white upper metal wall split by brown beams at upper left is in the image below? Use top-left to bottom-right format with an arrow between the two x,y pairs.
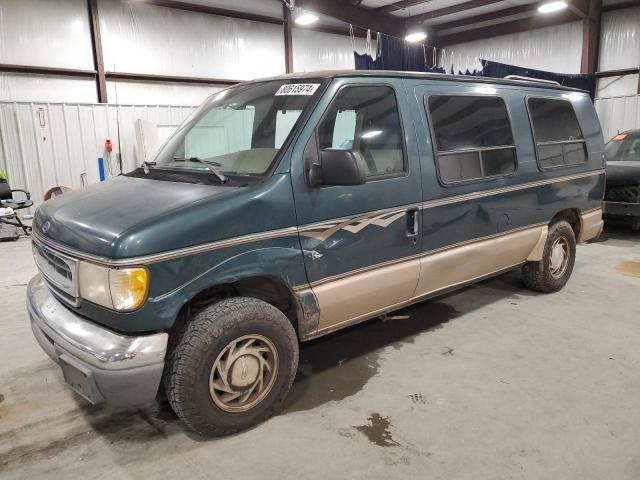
0,0 -> 360,105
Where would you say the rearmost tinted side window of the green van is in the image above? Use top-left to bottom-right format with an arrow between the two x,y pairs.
527,98 -> 587,170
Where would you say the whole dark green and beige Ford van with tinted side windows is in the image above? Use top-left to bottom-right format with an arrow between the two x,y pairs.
27,71 -> 605,435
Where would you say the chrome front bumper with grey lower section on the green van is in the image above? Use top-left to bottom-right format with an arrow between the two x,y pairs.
27,275 -> 168,405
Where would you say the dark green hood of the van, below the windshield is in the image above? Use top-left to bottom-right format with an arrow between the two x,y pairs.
33,176 -> 242,259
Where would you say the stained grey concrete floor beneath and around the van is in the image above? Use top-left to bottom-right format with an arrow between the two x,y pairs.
0,230 -> 640,480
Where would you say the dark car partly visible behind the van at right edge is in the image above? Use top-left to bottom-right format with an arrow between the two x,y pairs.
603,129 -> 640,230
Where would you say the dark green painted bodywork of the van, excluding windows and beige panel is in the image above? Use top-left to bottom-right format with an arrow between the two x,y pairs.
34,72 -> 604,336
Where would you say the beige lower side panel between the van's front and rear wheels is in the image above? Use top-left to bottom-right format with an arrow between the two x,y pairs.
312,225 -> 548,336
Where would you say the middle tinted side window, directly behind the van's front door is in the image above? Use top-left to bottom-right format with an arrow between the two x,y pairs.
427,95 -> 516,184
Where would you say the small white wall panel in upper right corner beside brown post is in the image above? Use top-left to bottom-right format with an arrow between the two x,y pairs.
598,7 -> 640,71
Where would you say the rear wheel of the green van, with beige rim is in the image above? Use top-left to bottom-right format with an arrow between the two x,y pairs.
522,221 -> 576,293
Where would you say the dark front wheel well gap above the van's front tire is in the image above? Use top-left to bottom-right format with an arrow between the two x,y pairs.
184,276 -> 299,333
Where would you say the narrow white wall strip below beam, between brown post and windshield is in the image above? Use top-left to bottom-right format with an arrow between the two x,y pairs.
107,80 -> 226,105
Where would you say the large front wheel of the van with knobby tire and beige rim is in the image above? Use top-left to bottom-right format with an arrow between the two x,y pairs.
165,297 -> 298,436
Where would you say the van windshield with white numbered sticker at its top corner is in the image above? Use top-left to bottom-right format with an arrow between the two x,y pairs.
152,79 -> 321,175
